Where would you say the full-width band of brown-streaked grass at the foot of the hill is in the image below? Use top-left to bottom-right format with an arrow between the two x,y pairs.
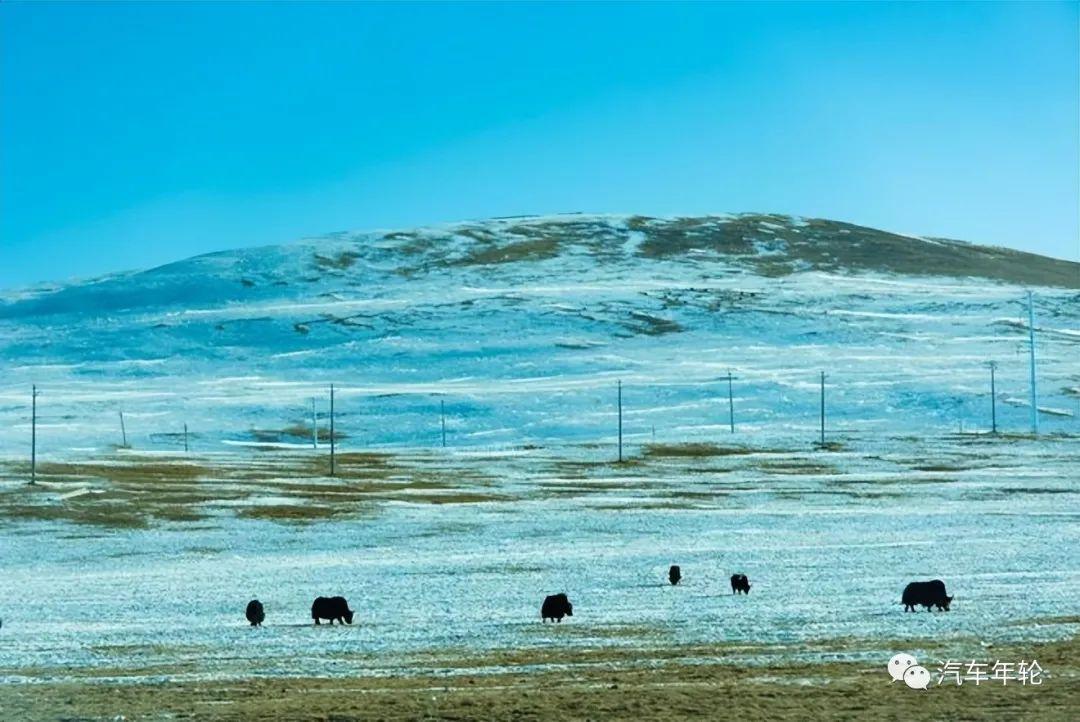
0,437 -> 1071,529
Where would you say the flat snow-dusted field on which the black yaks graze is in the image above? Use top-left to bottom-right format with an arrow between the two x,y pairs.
0,437 -> 1080,681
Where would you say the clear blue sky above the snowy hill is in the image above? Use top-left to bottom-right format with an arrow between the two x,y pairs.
0,2 -> 1080,287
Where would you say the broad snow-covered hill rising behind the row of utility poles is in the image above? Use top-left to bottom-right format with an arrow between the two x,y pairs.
0,215 -> 1080,457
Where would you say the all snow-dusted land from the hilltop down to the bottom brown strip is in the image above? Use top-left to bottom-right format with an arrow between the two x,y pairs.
0,216 -> 1080,680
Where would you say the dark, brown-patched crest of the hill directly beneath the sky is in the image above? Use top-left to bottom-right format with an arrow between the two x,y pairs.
0,213 -> 1080,316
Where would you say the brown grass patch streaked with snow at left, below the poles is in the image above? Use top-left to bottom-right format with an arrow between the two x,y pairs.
0,452 -> 505,529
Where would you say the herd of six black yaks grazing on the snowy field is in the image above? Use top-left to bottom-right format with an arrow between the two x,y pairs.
245,564 -> 953,627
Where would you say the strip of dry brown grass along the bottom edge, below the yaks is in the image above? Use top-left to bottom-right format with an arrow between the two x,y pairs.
0,639 -> 1080,722
